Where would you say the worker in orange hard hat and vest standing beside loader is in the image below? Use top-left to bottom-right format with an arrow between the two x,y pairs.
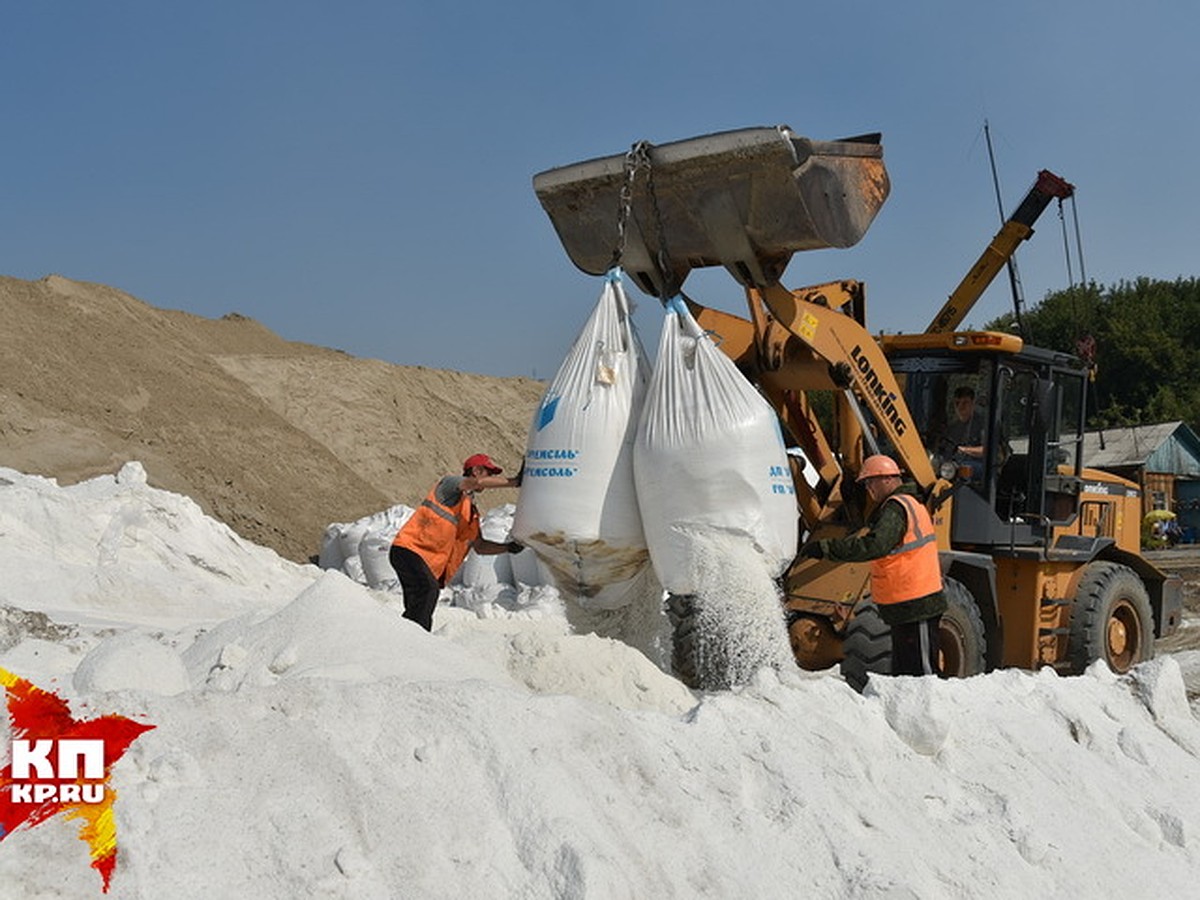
800,455 -> 947,676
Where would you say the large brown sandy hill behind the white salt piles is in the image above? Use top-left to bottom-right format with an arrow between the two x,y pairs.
0,275 -> 545,560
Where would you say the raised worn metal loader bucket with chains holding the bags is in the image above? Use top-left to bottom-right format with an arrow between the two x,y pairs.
533,125 -> 889,296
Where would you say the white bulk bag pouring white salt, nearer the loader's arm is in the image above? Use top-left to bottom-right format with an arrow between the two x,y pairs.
634,298 -> 798,594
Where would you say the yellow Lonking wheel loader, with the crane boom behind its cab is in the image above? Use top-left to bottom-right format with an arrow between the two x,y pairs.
533,126 -> 1181,689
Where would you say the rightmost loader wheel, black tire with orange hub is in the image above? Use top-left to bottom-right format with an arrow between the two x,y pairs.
1067,560 -> 1154,674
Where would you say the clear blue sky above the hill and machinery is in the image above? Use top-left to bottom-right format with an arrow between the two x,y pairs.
0,0 -> 1200,378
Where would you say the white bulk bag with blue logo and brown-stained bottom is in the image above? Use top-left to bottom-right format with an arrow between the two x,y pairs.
512,274 -> 650,608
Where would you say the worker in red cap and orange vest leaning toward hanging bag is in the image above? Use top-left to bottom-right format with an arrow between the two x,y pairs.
388,454 -> 524,631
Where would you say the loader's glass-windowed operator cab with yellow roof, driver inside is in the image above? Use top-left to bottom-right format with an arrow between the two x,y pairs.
882,332 -> 1086,550
